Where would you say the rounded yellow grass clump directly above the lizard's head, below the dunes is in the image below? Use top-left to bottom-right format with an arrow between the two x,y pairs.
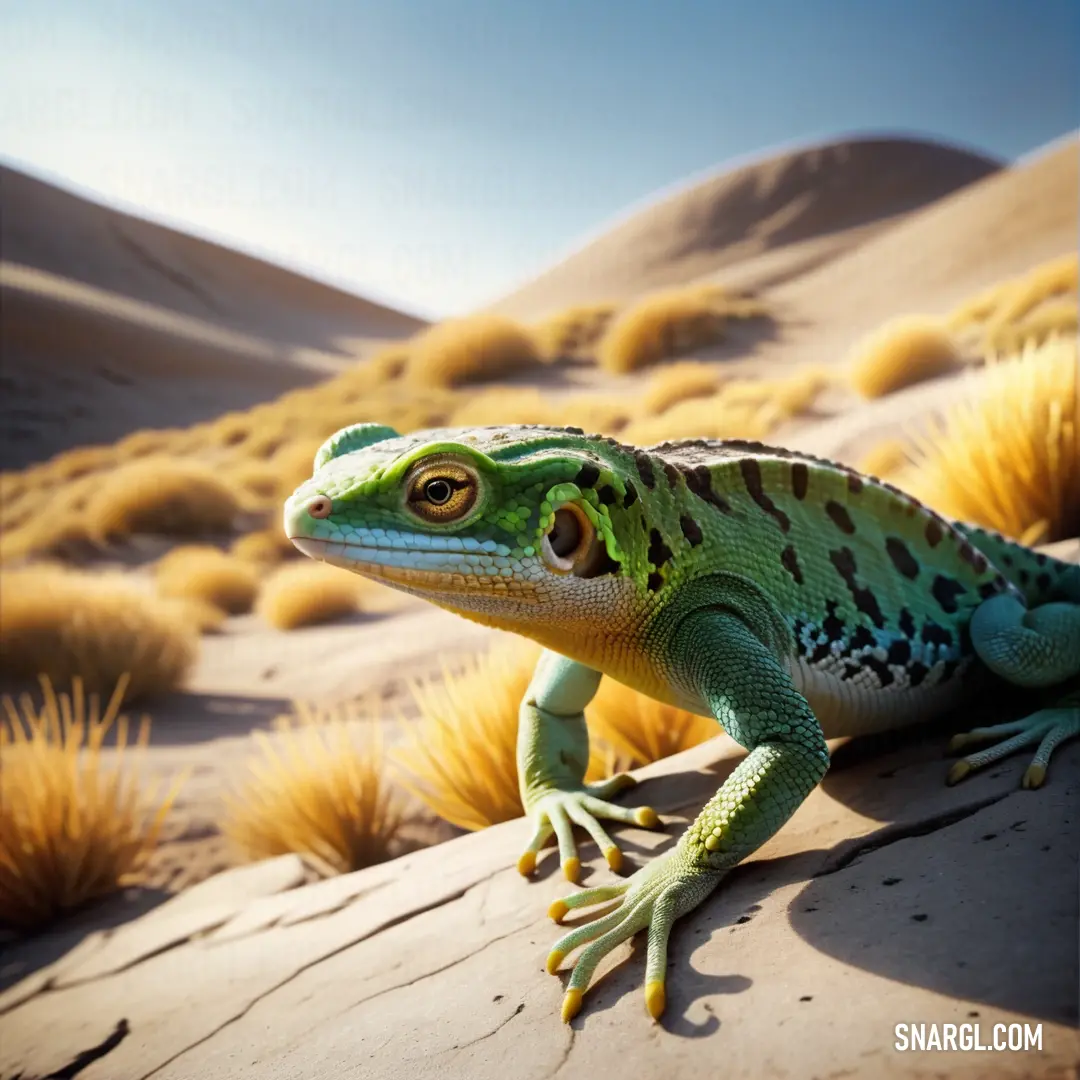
407,314 -> 541,387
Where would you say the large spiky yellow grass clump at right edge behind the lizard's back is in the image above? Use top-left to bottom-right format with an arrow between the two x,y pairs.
897,338 -> 1080,543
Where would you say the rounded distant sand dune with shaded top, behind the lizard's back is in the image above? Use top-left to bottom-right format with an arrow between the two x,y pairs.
492,138 -> 999,319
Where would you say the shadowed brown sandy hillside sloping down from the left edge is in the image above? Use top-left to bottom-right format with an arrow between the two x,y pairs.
0,167 -> 423,469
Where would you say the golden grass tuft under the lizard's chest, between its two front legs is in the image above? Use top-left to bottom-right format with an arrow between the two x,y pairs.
585,678 -> 723,769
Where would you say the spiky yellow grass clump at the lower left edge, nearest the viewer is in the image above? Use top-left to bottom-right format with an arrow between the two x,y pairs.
0,676 -> 180,931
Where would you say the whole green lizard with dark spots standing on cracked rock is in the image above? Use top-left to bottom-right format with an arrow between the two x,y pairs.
285,423 -> 1080,1021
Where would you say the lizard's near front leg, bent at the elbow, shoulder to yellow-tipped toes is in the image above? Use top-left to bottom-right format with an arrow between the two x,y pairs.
548,610 -> 828,1022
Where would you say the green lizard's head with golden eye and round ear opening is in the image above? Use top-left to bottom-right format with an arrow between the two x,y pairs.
284,423 -> 651,636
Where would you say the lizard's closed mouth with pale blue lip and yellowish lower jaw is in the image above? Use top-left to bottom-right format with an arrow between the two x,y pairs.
288,537 -> 537,599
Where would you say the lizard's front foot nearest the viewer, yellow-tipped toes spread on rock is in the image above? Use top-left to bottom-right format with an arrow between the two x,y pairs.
548,848 -> 724,1024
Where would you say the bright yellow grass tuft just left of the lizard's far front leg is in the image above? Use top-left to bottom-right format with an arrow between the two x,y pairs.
392,638 -> 613,829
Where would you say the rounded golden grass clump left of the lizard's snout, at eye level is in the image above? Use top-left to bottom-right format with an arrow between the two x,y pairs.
86,458 -> 241,537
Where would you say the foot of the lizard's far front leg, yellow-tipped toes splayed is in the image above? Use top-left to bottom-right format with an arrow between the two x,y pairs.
517,773 -> 660,881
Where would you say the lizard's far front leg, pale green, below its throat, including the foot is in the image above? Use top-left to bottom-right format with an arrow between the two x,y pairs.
517,650 -> 660,881
